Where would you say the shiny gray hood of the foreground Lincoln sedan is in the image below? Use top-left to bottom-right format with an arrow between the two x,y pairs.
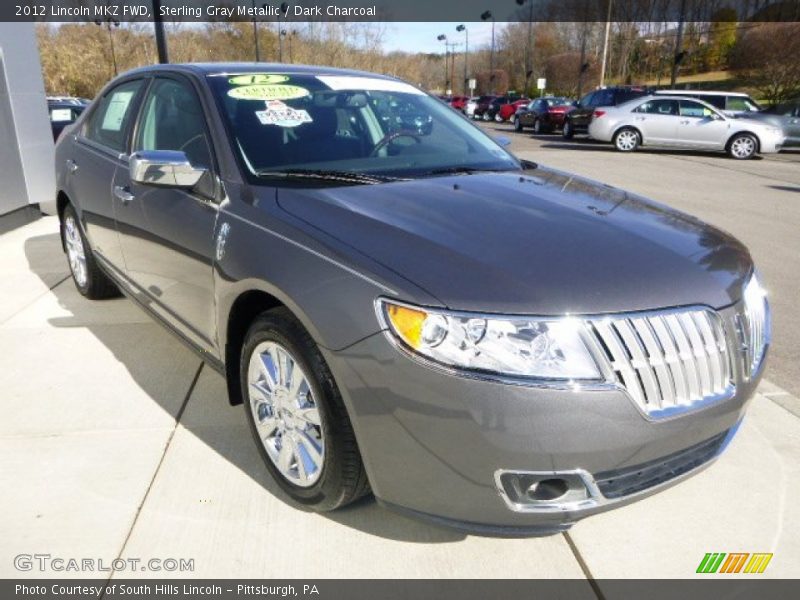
278,168 -> 752,315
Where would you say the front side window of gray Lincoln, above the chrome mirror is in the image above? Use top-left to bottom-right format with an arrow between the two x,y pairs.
133,79 -> 211,168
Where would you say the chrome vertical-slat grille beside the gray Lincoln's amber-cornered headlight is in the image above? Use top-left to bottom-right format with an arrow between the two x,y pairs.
587,309 -> 733,418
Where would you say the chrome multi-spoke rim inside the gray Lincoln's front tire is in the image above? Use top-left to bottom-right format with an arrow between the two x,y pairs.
247,342 -> 325,487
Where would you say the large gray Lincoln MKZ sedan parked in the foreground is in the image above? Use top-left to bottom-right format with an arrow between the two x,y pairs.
56,63 -> 769,534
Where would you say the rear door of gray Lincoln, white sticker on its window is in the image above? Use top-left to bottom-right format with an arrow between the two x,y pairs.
65,79 -> 143,271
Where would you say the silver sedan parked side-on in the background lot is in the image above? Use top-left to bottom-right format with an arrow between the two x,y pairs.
589,95 -> 784,159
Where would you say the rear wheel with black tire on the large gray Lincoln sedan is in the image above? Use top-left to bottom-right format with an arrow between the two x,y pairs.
61,204 -> 119,300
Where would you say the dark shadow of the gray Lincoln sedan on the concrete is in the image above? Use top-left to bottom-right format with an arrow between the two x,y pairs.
24,233 -> 466,544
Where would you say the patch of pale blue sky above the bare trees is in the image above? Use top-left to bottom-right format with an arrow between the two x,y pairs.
383,21 -> 503,54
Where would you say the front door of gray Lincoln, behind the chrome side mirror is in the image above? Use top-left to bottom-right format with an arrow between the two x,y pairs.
114,76 -> 218,351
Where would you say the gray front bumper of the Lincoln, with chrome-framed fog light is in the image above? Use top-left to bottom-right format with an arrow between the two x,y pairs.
325,308 -> 757,534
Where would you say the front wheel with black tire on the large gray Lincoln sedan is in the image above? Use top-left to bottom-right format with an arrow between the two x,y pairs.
239,308 -> 369,512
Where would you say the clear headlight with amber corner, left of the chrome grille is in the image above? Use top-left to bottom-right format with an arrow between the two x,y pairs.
378,300 -> 602,381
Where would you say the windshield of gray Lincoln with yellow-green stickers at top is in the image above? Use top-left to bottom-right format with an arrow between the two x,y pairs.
209,73 -> 520,180
